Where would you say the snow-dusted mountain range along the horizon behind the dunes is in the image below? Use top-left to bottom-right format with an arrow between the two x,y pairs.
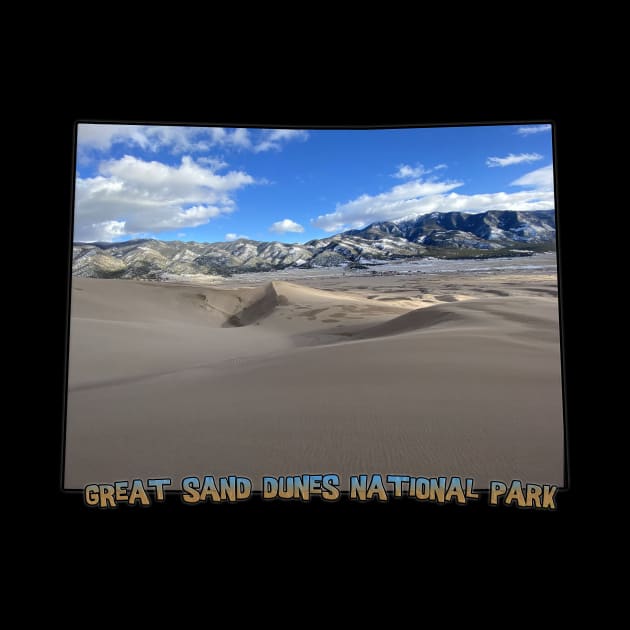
72,210 -> 556,279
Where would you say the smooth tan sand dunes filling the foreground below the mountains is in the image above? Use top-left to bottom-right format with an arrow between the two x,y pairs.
66,278 -> 563,488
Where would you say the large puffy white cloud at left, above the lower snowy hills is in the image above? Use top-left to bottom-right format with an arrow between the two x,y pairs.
75,155 -> 254,241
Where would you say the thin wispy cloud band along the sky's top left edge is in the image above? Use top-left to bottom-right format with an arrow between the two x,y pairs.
77,123 -> 308,156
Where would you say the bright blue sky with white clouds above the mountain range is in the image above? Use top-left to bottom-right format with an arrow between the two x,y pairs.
74,123 -> 554,243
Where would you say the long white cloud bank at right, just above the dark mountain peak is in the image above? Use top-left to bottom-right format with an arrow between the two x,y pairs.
311,174 -> 554,233
